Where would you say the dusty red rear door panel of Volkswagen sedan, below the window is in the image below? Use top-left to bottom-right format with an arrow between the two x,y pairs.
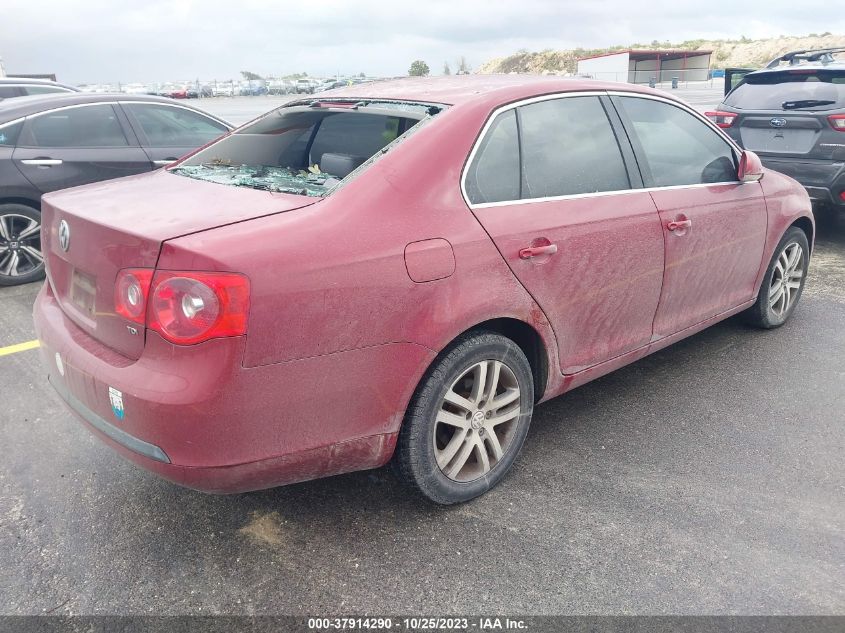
475,191 -> 663,374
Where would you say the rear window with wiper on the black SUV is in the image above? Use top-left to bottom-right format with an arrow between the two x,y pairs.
725,68 -> 845,110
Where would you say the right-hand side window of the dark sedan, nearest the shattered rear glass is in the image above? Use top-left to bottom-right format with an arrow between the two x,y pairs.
123,103 -> 229,147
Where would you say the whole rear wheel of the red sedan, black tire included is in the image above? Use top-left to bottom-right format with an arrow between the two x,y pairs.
395,332 -> 534,505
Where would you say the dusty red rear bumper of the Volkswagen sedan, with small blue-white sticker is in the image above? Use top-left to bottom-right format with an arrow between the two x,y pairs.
34,284 -> 433,493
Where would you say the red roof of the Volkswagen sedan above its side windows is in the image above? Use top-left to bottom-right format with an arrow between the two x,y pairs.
304,74 -> 667,105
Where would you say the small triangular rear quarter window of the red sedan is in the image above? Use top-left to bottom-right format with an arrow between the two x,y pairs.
466,110 -> 520,204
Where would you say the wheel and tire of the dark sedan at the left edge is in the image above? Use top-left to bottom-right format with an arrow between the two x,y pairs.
0,203 -> 44,286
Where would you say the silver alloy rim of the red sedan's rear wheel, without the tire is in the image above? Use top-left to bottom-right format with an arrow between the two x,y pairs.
433,360 -> 521,483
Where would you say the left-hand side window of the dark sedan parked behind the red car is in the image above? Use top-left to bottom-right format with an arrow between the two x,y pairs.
18,104 -> 129,147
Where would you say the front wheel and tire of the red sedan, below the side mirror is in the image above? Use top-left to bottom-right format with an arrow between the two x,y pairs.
744,226 -> 810,330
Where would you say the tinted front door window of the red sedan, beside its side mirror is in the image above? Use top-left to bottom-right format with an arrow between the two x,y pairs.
616,97 -> 737,187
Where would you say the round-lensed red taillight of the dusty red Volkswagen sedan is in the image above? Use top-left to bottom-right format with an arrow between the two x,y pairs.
115,269 -> 249,345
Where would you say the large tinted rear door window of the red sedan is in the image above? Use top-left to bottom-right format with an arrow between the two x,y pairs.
519,97 -> 631,198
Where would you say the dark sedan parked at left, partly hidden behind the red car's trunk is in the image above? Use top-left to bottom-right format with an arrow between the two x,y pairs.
0,93 -> 233,286
